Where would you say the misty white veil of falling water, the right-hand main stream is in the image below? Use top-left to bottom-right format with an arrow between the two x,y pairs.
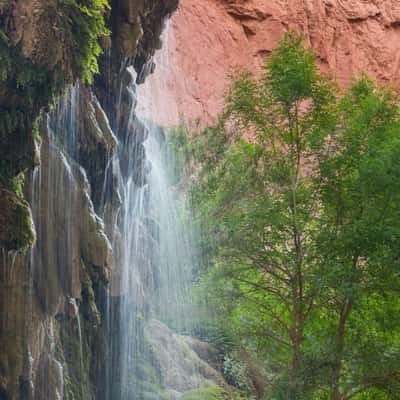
110,68 -> 196,400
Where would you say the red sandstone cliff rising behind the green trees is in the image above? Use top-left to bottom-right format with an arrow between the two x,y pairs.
142,0 -> 400,123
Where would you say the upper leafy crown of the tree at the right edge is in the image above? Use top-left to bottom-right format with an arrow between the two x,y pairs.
320,78 -> 400,256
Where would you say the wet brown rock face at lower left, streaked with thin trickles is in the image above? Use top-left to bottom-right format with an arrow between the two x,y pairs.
0,107 -> 111,400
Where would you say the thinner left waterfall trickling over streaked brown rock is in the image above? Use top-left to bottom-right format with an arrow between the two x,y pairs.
26,85 -> 111,400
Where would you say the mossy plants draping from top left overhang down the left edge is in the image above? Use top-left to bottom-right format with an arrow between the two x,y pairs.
0,0 -> 109,250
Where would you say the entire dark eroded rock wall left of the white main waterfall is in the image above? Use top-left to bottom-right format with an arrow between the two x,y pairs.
0,0 -> 177,400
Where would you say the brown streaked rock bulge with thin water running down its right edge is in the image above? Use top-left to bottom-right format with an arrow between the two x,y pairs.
31,121 -> 111,316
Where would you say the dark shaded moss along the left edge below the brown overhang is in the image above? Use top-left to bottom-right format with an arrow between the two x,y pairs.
0,24 -> 64,195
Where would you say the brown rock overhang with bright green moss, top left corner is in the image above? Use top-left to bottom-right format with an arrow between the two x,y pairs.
1,0 -> 109,81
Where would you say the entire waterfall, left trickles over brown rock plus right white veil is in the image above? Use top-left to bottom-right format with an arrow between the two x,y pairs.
15,20 -> 202,400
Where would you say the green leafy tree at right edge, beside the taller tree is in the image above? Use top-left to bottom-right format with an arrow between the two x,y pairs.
318,77 -> 400,400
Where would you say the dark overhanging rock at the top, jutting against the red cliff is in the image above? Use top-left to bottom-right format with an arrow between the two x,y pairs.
94,0 -> 179,115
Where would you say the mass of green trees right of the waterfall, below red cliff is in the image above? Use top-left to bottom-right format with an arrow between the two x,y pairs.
175,32 -> 400,400
